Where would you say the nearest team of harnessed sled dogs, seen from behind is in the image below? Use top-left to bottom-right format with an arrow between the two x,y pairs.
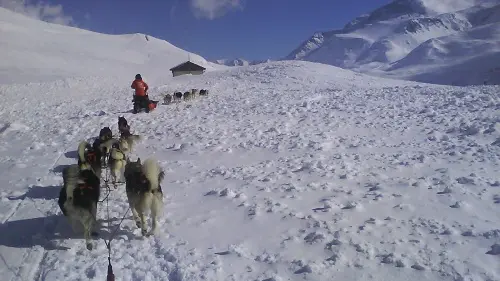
58,117 -> 165,250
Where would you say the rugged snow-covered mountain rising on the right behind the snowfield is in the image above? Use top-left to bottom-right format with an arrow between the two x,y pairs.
285,0 -> 500,85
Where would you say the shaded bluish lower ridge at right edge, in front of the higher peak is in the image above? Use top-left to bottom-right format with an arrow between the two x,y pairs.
380,23 -> 500,85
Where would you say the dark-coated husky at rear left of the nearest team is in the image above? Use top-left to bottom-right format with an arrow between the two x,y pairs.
57,164 -> 100,251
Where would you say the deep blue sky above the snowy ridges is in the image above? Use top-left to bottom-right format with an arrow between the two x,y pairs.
0,0 -> 390,60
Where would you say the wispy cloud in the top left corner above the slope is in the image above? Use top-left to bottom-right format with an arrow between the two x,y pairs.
0,0 -> 74,25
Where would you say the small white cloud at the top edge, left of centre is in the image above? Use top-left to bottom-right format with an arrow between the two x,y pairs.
190,0 -> 243,20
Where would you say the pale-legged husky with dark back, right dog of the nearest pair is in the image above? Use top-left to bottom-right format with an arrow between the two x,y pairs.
124,158 -> 165,236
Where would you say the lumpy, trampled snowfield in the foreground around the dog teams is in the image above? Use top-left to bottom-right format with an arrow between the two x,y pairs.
0,57 -> 500,281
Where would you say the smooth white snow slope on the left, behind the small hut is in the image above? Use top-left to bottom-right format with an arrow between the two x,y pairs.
0,8 -> 218,83
